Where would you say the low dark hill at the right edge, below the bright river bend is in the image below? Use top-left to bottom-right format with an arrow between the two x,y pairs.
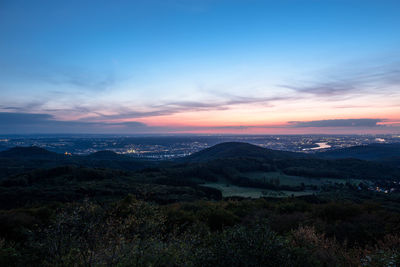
316,143 -> 400,161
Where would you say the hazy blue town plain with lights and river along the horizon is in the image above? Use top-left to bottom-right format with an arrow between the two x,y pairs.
0,135 -> 400,159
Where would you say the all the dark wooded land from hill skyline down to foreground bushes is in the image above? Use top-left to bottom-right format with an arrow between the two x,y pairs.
0,143 -> 400,266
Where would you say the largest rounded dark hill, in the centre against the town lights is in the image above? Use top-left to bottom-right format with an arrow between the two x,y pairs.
184,142 -> 306,162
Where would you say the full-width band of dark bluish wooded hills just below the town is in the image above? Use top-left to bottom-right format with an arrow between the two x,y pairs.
0,142 -> 400,182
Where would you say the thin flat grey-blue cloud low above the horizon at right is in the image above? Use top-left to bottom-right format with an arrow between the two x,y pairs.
288,119 -> 383,127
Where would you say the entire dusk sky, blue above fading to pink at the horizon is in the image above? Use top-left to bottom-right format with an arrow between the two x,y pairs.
0,0 -> 400,134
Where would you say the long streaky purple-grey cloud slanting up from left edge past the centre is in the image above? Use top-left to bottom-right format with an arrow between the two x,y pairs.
0,90 -> 290,122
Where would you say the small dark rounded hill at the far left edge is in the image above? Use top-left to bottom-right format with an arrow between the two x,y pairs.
0,146 -> 63,158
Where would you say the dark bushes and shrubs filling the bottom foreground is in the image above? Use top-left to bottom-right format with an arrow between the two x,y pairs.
0,195 -> 400,266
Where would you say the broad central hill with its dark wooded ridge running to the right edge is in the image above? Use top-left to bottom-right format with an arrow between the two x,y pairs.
173,142 -> 400,182
